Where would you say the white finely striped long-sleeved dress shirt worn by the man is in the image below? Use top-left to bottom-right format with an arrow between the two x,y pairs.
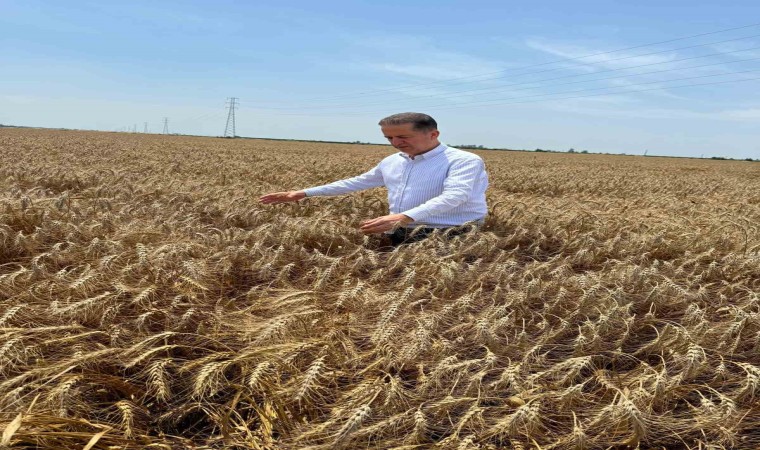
304,144 -> 488,228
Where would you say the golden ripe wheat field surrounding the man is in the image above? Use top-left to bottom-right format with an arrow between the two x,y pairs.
0,129 -> 760,450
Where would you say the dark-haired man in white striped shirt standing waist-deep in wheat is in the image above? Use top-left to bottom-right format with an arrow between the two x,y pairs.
259,113 -> 488,246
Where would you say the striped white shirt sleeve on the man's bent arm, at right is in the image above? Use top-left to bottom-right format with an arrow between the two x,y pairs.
401,158 -> 485,222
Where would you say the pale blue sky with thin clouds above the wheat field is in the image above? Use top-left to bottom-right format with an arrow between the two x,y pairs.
0,0 -> 760,158
